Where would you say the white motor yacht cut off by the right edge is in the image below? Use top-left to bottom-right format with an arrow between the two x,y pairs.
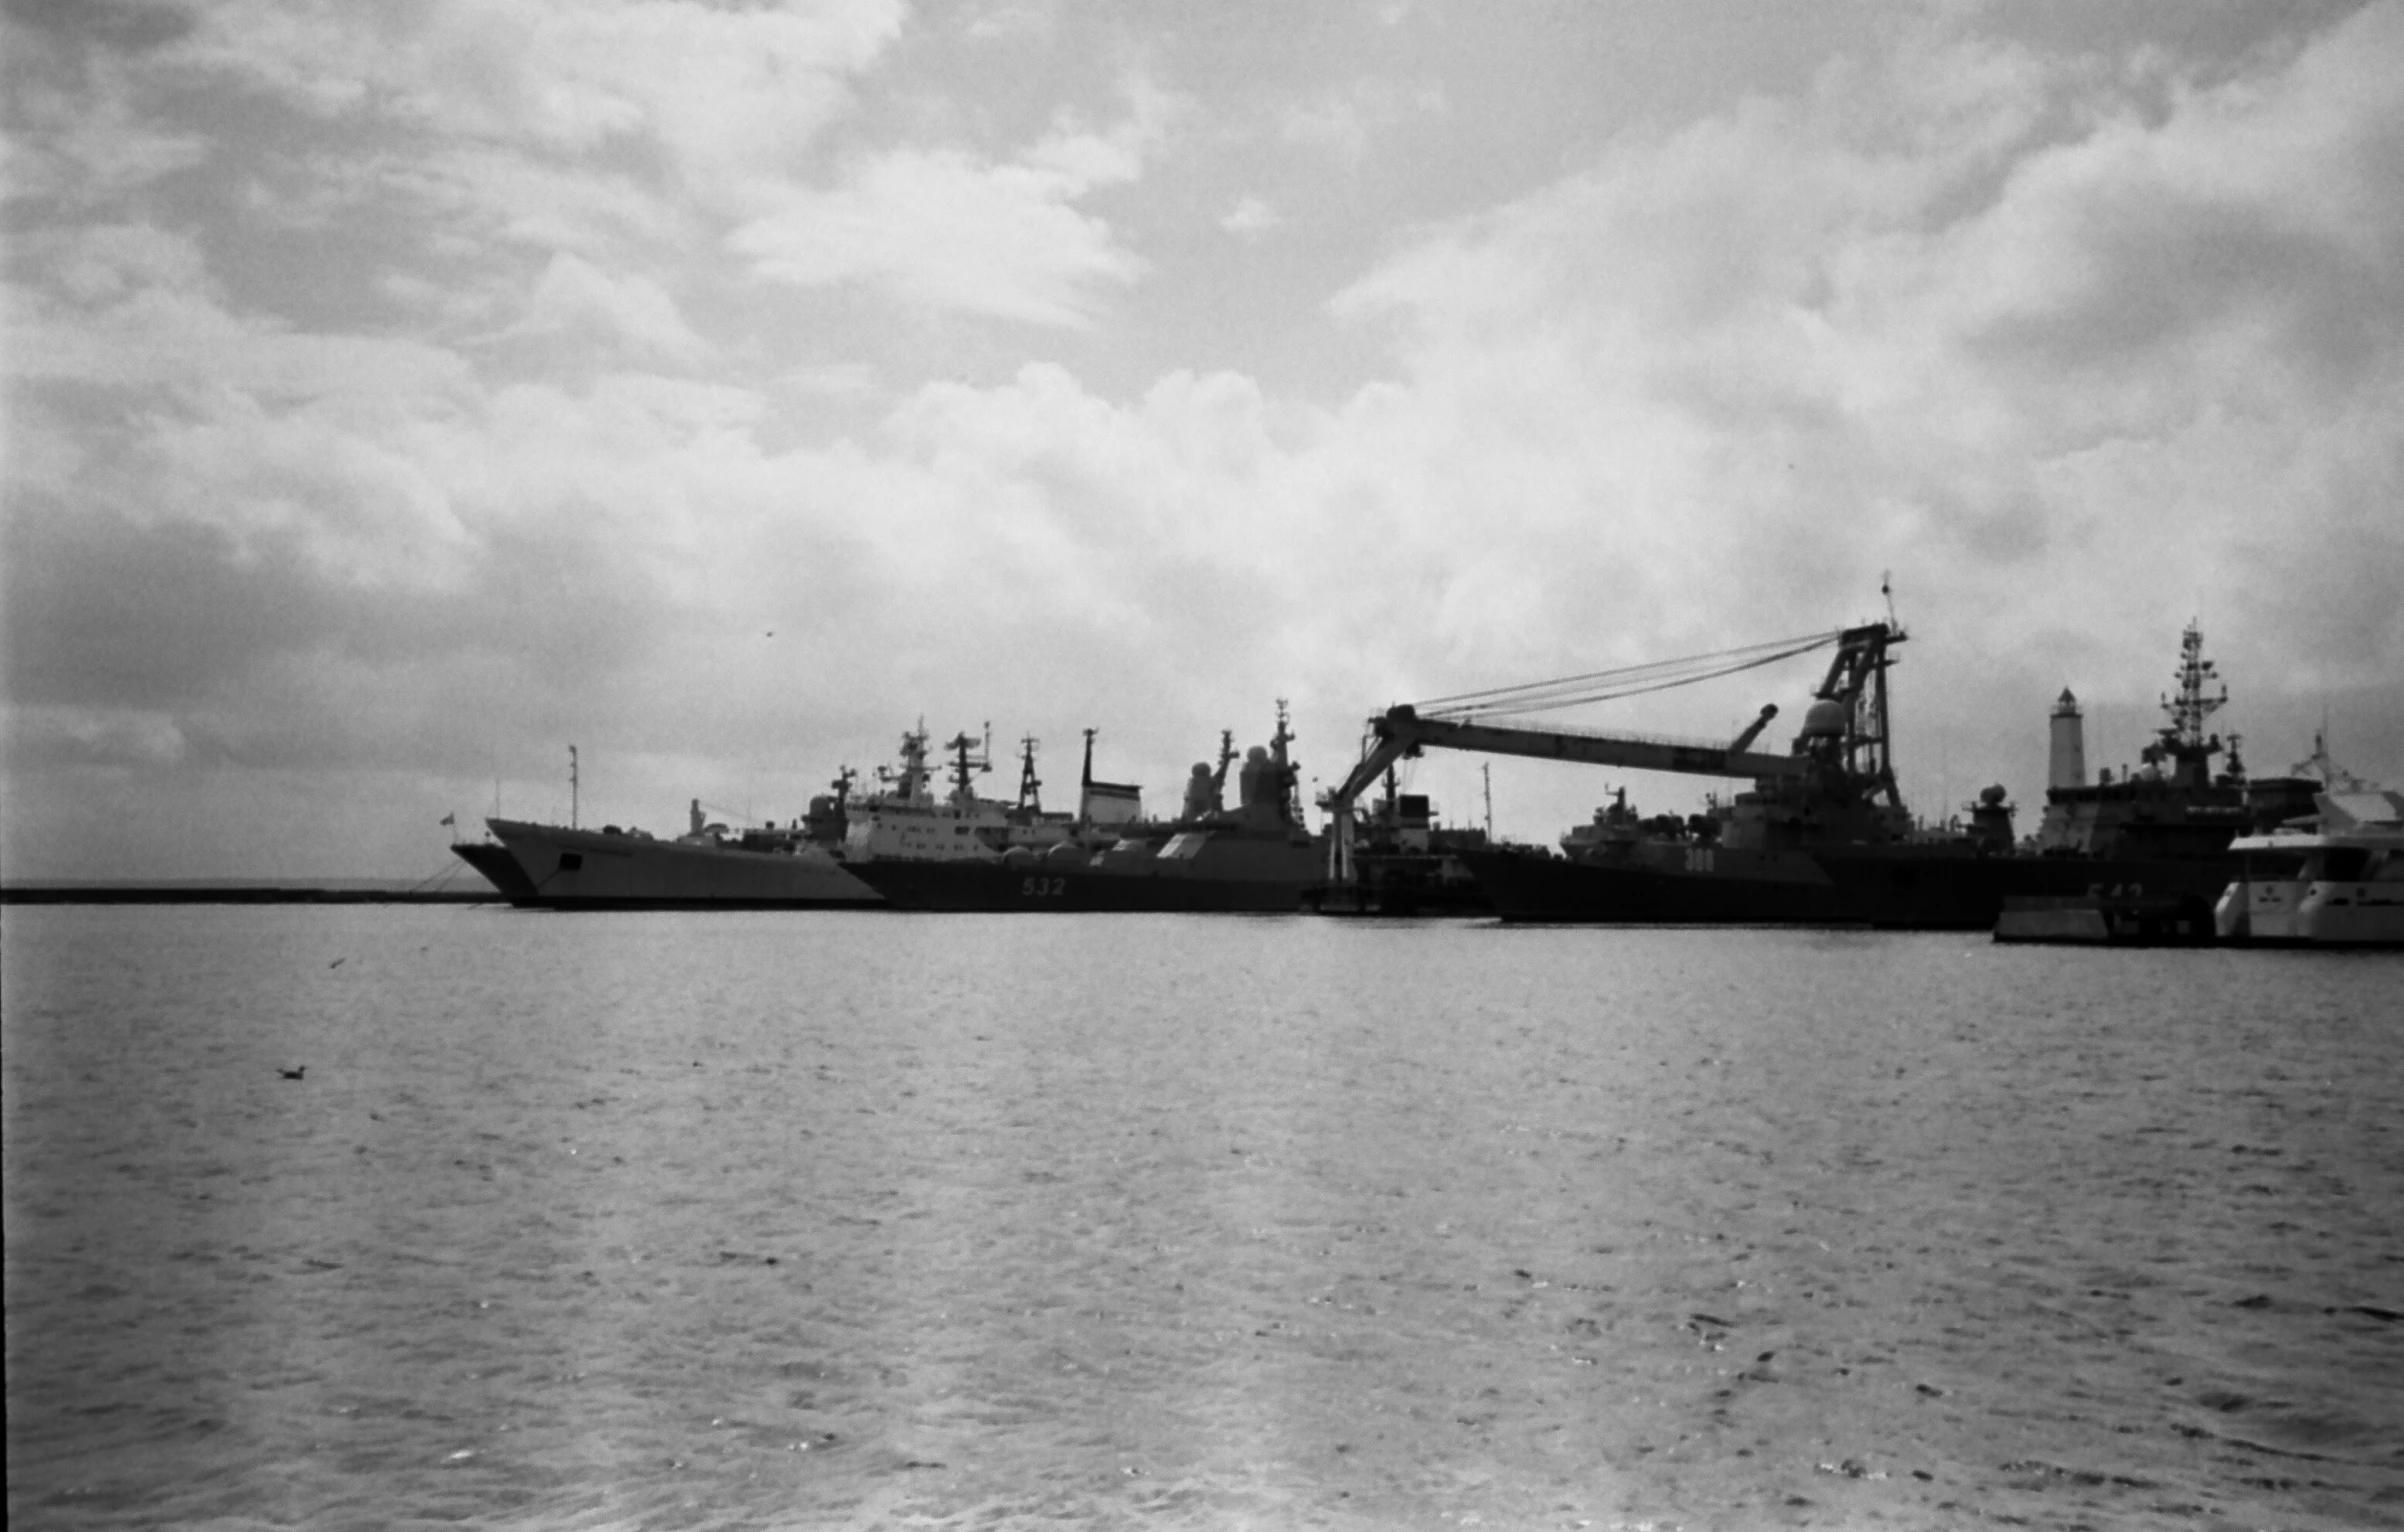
2214,786 -> 2404,948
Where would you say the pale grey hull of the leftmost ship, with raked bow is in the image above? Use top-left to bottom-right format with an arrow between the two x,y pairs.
488,820 -> 882,909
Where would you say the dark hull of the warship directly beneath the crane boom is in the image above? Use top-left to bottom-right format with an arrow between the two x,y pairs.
1462,851 -> 1861,926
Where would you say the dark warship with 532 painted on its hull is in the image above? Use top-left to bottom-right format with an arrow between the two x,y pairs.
851,702 -> 1320,914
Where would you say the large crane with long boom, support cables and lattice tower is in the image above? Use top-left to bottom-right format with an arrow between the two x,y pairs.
1320,623 -> 1904,883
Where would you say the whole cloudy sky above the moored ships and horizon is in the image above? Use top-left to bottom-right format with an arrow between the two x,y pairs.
0,0 -> 2404,880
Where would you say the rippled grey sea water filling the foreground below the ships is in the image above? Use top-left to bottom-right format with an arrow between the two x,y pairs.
0,907 -> 2404,1530
